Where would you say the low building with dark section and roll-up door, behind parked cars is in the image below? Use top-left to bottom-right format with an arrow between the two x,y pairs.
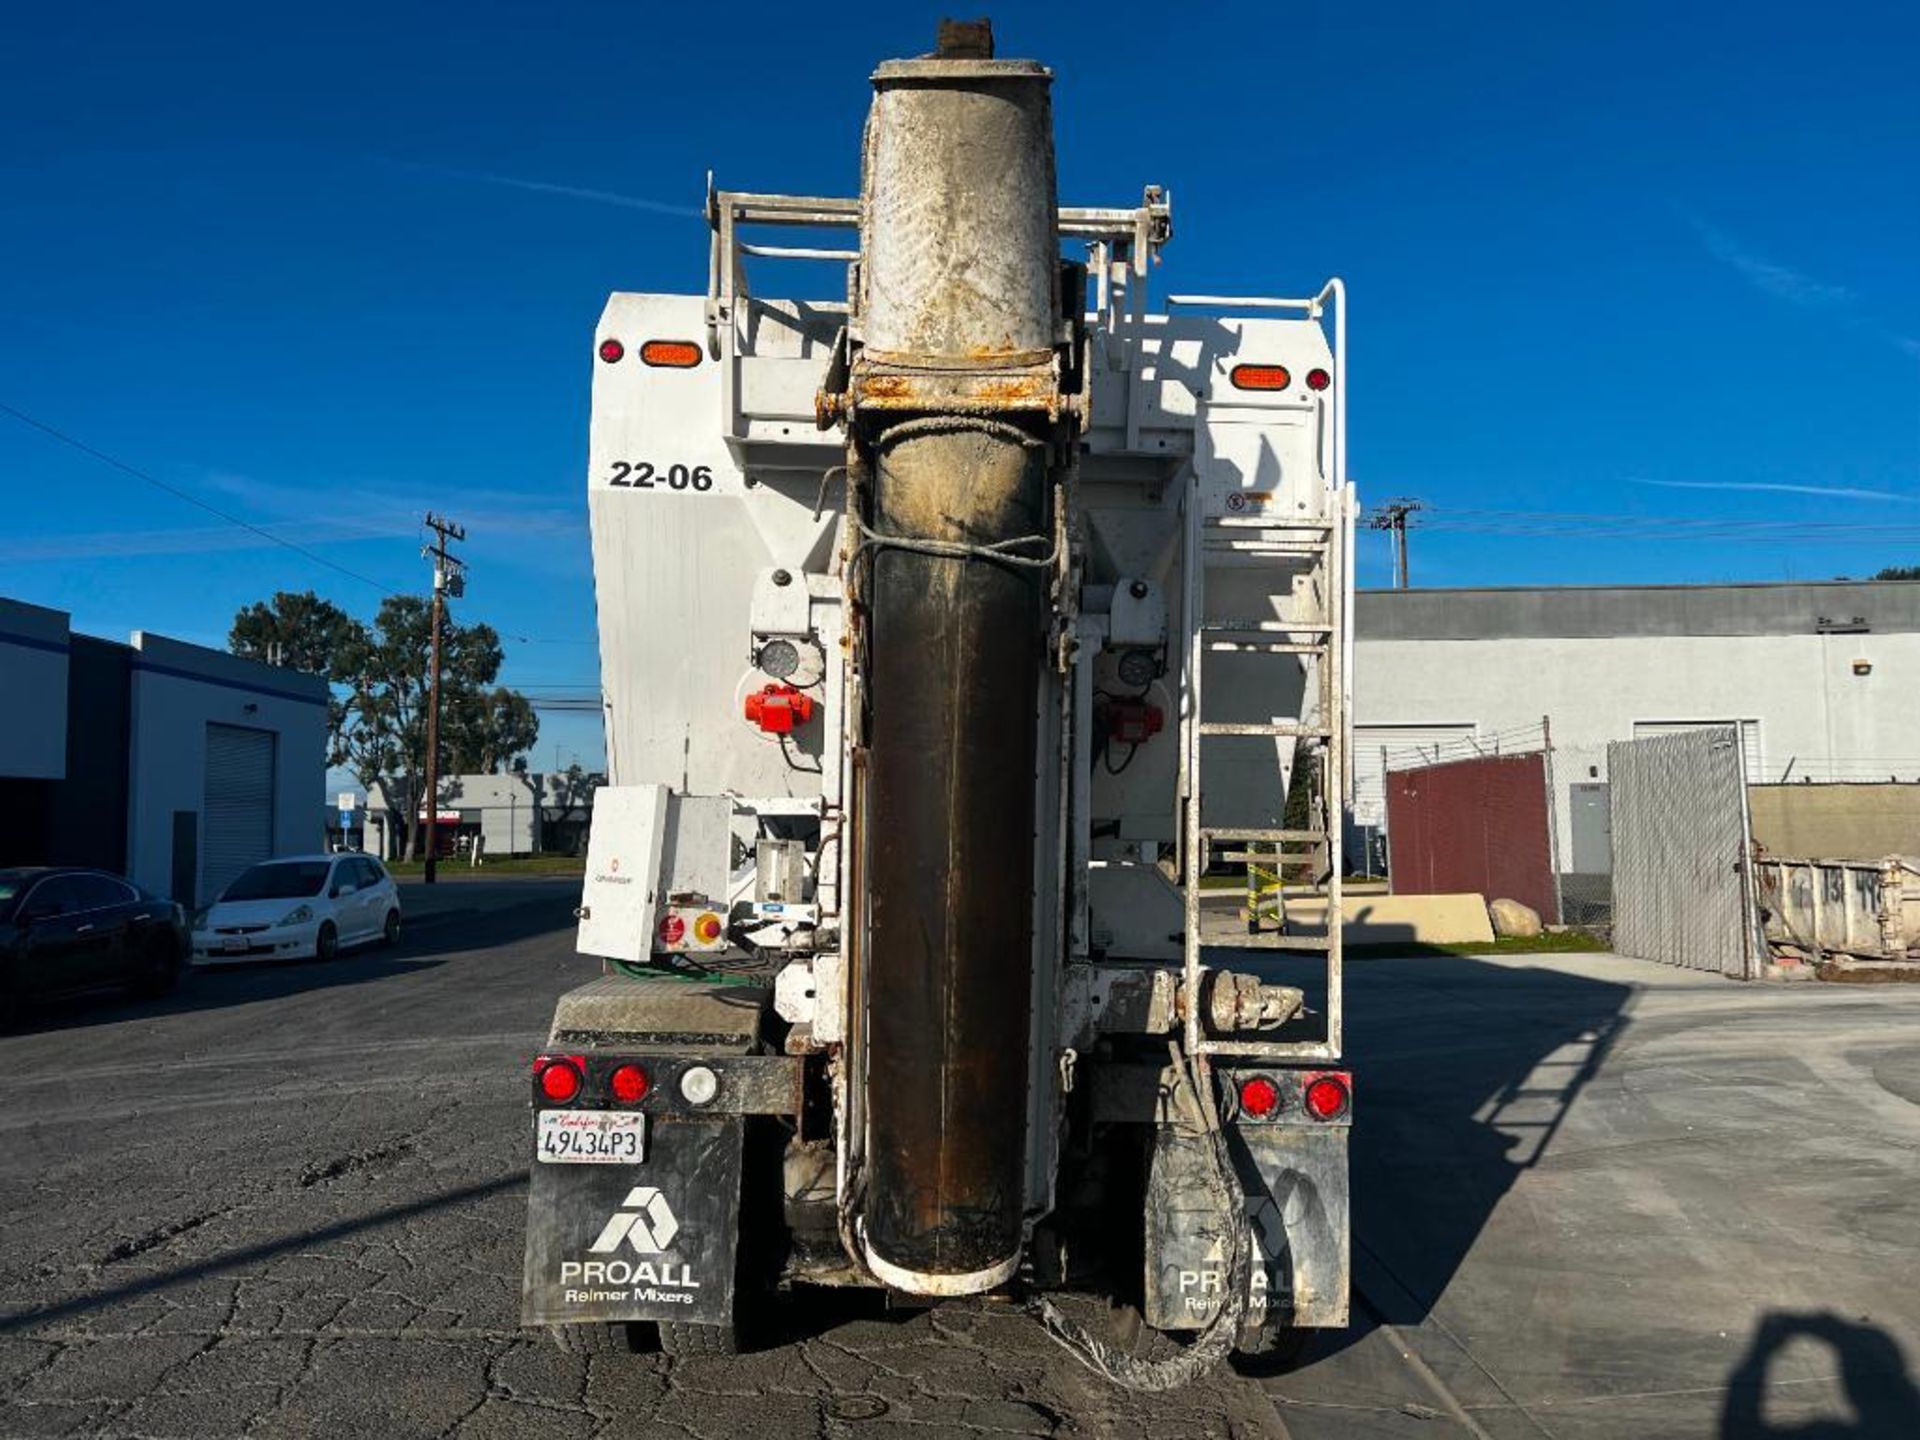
0,601 -> 326,904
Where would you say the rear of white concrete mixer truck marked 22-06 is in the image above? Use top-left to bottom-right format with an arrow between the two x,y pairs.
522,16 -> 1354,1388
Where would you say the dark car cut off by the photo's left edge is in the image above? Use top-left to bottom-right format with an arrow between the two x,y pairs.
0,868 -> 188,1023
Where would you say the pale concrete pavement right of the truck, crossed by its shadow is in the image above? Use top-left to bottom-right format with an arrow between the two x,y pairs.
1267,954 -> 1920,1440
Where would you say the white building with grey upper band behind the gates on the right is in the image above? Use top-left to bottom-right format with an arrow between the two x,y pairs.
1354,580 -> 1920,874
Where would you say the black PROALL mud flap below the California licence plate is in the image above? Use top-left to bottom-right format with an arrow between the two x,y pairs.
520,1114 -> 745,1325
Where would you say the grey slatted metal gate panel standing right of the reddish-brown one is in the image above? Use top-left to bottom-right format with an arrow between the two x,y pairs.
1607,726 -> 1759,979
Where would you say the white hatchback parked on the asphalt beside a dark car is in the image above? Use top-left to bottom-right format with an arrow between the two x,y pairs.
194,854 -> 399,966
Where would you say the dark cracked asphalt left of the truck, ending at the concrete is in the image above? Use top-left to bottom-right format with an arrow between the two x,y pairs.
0,879 -> 1281,1440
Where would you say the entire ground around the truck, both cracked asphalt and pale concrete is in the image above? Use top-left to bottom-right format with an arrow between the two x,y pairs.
0,879 -> 1920,1440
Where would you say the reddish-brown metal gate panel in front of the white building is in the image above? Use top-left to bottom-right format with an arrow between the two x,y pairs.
1386,755 -> 1559,924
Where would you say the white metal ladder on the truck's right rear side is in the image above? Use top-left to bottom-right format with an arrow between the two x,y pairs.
1179,503 -> 1346,1060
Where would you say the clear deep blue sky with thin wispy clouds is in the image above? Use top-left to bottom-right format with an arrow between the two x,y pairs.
0,0 -> 1920,779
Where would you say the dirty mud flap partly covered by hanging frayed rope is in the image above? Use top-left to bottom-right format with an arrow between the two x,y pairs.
1144,1123 -> 1350,1331
